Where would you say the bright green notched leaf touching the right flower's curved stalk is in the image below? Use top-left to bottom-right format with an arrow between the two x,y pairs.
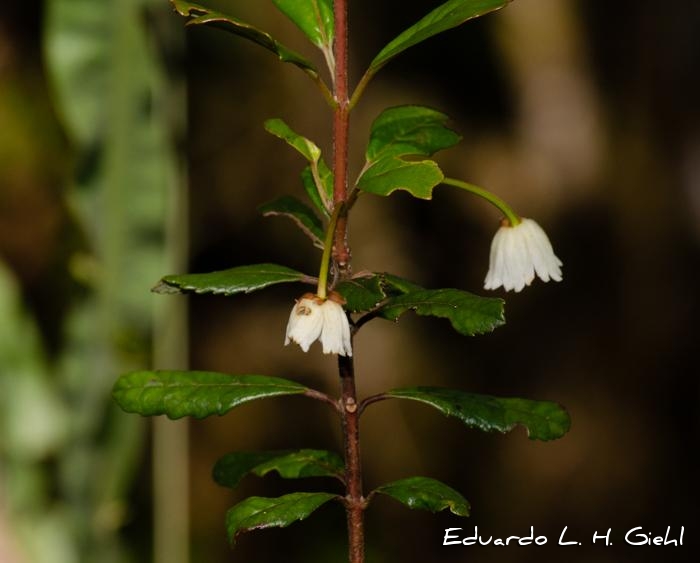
357,157 -> 445,199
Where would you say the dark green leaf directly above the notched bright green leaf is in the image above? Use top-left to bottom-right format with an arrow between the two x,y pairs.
366,106 -> 461,163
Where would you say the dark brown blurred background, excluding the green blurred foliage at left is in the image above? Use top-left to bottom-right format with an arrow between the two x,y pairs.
0,0 -> 700,563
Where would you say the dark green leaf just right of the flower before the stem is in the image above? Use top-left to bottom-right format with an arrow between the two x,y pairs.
381,289 -> 505,336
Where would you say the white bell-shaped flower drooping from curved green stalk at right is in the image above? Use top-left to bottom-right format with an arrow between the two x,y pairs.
484,218 -> 562,291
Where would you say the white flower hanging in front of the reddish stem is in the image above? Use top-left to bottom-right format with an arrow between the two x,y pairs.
284,293 -> 352,356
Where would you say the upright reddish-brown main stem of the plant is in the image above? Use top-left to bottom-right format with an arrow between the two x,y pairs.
333,0 -> 366,563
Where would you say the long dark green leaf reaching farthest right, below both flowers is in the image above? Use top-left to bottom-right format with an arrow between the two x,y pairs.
387,387 -> 571,441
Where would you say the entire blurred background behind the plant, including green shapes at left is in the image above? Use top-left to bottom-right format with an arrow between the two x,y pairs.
0,0 -> 700,563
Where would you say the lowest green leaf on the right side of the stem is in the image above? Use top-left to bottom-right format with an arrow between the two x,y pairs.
372,477 -> 470,516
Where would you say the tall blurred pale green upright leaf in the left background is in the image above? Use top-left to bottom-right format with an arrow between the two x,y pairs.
43,0 -> 186,562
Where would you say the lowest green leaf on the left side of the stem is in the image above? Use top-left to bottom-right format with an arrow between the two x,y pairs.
226,493 -> 337,544
